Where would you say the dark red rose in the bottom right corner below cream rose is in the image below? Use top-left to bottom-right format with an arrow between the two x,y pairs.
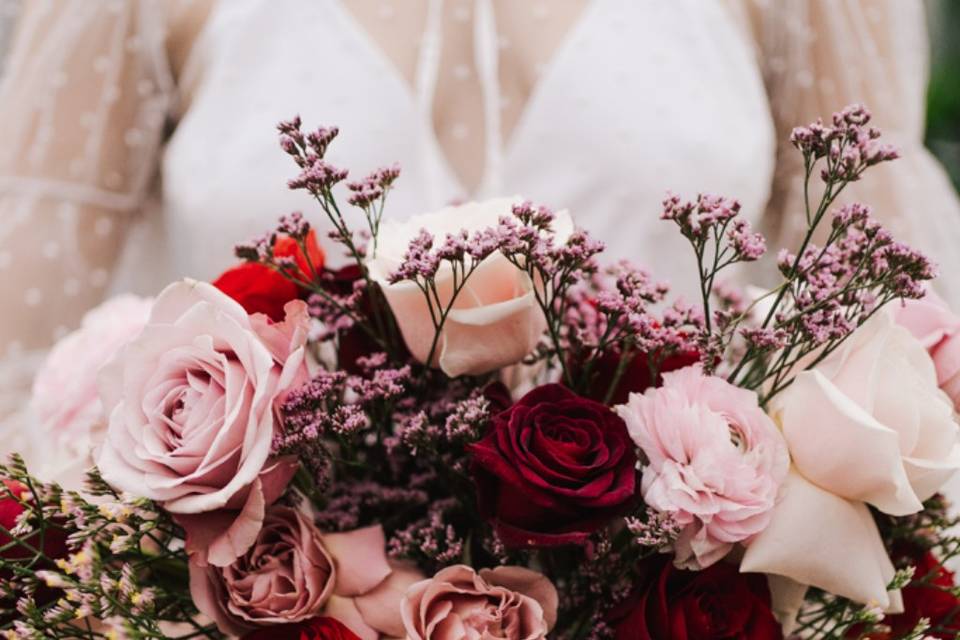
848,551 -> 960,640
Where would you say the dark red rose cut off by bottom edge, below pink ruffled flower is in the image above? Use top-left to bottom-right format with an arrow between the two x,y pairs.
610,556 -> 783,640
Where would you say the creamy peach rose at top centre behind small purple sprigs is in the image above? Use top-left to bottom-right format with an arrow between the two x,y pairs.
367,198 -> 573,377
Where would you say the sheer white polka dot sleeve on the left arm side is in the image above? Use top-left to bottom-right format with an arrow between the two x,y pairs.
0,0 -> 172,417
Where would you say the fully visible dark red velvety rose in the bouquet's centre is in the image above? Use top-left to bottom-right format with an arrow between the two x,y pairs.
469,384 -> 637,547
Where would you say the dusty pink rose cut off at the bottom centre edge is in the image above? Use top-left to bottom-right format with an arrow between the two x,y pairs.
401,564 -> 557,640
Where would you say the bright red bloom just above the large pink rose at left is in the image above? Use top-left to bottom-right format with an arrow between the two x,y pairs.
213,229 -> 324,322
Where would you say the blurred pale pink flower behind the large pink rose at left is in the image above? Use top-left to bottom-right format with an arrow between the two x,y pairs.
30,295 -> 153,443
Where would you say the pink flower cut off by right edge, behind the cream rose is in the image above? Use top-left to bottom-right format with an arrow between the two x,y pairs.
894,291 -> 960,410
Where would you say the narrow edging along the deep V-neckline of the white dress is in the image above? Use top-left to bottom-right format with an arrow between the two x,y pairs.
329,0 -> 601,199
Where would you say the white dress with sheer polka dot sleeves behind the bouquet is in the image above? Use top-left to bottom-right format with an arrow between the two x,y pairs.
0,0 -> 960,480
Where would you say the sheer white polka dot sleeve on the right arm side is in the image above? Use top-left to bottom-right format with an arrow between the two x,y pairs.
750,0 -> 960,305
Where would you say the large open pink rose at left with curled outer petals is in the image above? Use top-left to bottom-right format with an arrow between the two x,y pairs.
97,280 -> 309,566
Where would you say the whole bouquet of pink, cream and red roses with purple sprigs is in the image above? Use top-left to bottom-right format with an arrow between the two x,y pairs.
0,105 -> 960,640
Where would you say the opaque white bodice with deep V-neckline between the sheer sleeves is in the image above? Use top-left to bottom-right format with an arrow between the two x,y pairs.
142,0 -> 774,298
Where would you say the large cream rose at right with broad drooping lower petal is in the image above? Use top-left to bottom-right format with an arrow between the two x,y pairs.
742,312 -> 960,609
